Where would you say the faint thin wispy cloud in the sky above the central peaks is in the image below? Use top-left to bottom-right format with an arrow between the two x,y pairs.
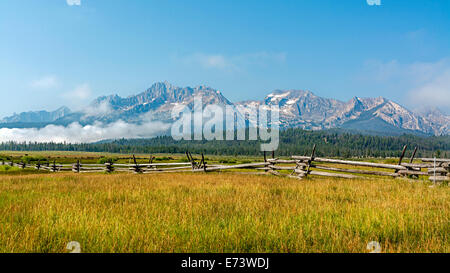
177,51 -> 287,71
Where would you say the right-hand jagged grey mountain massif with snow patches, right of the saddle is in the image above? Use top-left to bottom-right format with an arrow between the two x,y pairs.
236,90 -> 450,135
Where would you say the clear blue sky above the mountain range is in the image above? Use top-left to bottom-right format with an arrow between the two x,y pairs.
0,0 -> 450,117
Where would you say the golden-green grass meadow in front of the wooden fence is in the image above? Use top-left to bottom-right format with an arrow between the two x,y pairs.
0,173 -> 450,253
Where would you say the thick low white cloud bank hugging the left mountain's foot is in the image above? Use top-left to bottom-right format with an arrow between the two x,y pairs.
0,120 -> 170,143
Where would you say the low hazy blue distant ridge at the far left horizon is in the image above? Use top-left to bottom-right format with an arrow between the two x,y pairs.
0,106 -> 71,123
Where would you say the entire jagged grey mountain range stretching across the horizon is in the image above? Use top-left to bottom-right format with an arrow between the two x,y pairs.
0,82 -> 450,138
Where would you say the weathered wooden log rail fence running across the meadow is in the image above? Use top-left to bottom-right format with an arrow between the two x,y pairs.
1,146 -> 450,182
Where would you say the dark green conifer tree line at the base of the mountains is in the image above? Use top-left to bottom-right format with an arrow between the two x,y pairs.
0,129 -> 450,158
